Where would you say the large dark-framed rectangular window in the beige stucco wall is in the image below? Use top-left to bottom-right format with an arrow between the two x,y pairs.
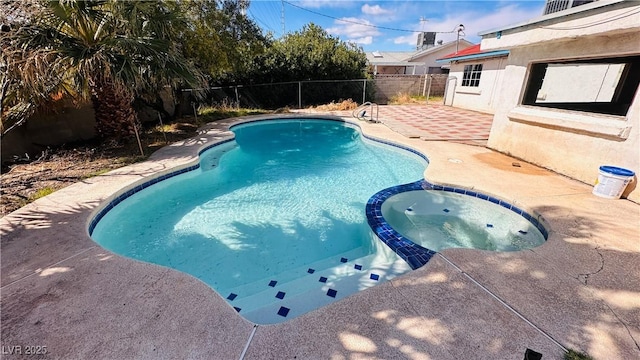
522,56 -> 640,116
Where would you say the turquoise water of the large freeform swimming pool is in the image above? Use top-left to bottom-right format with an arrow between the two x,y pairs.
91,119 -> 427,323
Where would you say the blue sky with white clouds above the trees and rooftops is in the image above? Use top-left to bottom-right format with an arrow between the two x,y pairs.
247,0 -> 545,51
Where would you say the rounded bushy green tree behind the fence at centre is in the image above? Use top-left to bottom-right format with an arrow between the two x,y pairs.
254,23 -> 367,82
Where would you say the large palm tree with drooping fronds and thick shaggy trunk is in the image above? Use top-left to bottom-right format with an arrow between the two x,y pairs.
1,0 -> 199,138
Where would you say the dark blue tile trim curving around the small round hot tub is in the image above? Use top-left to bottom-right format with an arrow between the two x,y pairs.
365,180 -> 549,269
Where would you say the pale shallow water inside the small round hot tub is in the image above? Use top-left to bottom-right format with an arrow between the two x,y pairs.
381,190 -> 545,251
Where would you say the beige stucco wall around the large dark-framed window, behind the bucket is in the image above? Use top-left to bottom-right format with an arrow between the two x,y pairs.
483,31 -> 640,202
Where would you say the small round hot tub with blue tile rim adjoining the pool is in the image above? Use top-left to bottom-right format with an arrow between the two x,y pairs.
367,181 -> 548,268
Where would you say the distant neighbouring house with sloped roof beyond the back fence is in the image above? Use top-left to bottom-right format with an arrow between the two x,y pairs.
366,39 -> 473,75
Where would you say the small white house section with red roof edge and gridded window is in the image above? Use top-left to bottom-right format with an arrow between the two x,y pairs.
436,44 -> 509,114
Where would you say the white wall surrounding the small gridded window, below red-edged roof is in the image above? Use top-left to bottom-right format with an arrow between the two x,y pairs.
448,57 -> 507,114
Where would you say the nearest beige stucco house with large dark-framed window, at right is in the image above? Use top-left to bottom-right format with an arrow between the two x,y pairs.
449,0 -> 640,202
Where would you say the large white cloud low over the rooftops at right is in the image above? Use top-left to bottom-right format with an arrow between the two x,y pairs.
393,5 -> 542,46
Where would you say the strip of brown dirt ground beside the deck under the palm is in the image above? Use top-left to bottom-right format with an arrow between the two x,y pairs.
0,122 -> 197,217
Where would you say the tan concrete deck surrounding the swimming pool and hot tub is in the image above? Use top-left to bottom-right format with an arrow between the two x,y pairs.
0,109 -> 640,359
